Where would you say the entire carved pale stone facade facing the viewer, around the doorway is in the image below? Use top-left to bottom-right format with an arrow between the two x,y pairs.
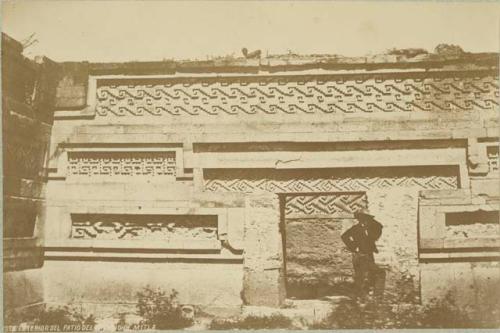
4,32 -> 500,316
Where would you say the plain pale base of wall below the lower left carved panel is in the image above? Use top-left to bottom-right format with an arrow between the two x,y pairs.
43,258 -> 243,308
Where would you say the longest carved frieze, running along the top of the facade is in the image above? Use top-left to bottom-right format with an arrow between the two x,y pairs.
96,75 -> 500,117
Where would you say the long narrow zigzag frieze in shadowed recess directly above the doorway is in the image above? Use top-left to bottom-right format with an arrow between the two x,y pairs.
205,170 -> 458,193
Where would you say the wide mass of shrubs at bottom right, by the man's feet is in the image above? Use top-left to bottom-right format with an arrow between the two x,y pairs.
313,272 -> 500,329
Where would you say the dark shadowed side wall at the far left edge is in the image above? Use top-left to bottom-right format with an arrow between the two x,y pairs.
2,34 -> 58,311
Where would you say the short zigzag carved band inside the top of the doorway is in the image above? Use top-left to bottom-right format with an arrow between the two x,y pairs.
285,193 -> 367,218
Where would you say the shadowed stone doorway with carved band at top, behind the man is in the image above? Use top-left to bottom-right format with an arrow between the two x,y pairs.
281,192 -> 368,299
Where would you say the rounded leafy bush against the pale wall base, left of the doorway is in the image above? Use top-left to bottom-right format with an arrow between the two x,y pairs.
137,287 -> 193,329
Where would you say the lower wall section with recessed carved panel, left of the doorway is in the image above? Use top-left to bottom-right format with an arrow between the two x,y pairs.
44,185 -> 245,315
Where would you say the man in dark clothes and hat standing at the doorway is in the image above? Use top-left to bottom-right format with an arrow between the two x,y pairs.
341,211 -> 382,294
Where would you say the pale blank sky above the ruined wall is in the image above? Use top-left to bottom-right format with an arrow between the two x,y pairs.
2,0 -> 500,62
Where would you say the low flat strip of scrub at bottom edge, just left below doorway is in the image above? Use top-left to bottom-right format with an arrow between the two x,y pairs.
209,314 -> 293,330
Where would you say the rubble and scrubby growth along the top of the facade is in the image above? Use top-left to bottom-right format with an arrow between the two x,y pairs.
90,44 -> 499,74
